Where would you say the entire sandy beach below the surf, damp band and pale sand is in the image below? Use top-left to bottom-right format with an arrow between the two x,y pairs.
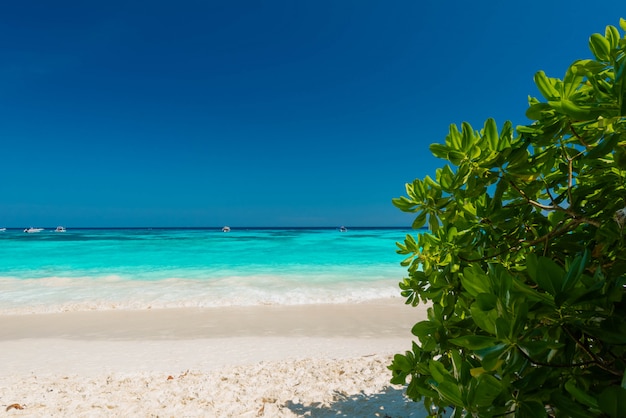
0,299 -> 426,418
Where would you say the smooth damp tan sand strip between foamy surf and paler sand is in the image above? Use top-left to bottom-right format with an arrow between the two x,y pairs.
0,298 -> 426,341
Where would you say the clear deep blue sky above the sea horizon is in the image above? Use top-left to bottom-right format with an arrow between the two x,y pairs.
0,0 -> 626,228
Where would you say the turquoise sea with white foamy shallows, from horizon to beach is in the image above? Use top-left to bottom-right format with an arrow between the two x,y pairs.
0,228 -> 415,314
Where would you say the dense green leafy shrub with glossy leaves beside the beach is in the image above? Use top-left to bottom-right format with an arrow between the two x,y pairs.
389,19 -> 626,418
